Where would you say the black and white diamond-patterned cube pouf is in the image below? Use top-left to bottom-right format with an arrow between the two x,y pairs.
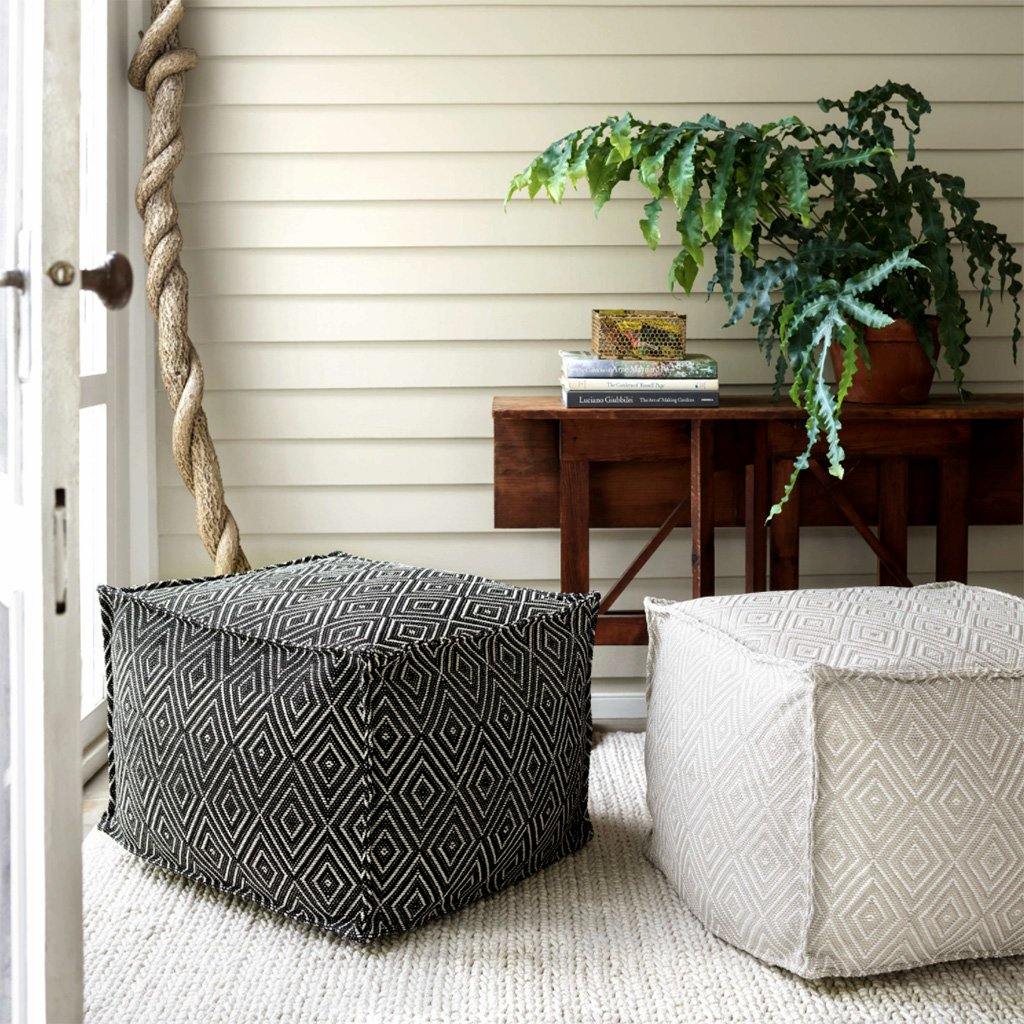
99,553 -> 598,940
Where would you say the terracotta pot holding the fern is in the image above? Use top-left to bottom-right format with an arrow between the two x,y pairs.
829,316 -> 939,406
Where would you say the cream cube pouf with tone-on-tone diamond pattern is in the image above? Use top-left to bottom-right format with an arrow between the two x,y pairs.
645,584 -> 1024,978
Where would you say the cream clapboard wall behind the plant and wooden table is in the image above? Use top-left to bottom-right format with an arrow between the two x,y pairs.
167,0 -> 1024,718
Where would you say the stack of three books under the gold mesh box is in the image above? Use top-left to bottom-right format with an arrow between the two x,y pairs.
560,352 -> 718,409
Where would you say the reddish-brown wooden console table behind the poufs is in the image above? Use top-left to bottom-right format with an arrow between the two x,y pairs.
494,393 -> 1024,644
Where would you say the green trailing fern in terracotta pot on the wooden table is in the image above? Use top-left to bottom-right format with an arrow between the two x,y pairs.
508,82 -> 1022,514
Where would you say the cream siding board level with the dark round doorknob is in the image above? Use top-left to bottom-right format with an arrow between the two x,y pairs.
182,246 -> 1020,295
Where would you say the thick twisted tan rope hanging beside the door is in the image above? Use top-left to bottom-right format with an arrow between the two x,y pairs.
128,0 -> 249,574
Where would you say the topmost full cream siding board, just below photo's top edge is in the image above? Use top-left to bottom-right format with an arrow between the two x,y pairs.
182,4 -> 1024,58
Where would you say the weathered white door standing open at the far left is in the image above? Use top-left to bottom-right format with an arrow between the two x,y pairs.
0,0 -> 136,1024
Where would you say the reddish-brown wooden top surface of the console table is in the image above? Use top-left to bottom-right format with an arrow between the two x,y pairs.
494,390 -> 1024,420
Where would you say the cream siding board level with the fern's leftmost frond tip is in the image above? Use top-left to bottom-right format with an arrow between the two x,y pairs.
175,150 -> 1024,200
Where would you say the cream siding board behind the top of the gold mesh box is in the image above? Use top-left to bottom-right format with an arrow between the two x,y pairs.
189,292 -> 1013,348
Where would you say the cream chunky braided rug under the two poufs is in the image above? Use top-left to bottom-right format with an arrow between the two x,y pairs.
85,732 -> 1024,1024
